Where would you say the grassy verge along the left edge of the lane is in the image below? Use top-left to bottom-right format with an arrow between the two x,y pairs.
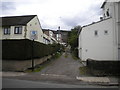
24,52 -> 62,73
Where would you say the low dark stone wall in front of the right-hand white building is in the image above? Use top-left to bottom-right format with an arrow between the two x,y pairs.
86,59 -> 120,75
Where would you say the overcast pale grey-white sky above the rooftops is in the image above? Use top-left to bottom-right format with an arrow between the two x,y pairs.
0,0 -> 104,30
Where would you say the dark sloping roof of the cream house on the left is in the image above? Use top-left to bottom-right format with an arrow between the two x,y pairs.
0,15 -> 37,26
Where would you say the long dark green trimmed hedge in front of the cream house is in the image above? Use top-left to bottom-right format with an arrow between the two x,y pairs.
2,39 -> 60,60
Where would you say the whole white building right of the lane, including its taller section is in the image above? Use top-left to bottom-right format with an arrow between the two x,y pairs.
78,0 -> 120,61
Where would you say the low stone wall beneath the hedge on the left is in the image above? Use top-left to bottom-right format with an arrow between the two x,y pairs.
2,55 -> 52,71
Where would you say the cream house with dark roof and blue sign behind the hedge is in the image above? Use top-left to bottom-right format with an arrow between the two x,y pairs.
0,15 -> 43,43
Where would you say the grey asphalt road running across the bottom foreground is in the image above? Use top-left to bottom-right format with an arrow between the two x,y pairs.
2,78 -> 117,88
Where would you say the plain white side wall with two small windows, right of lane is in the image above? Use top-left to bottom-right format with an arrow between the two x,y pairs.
79,19 -> 115,61
